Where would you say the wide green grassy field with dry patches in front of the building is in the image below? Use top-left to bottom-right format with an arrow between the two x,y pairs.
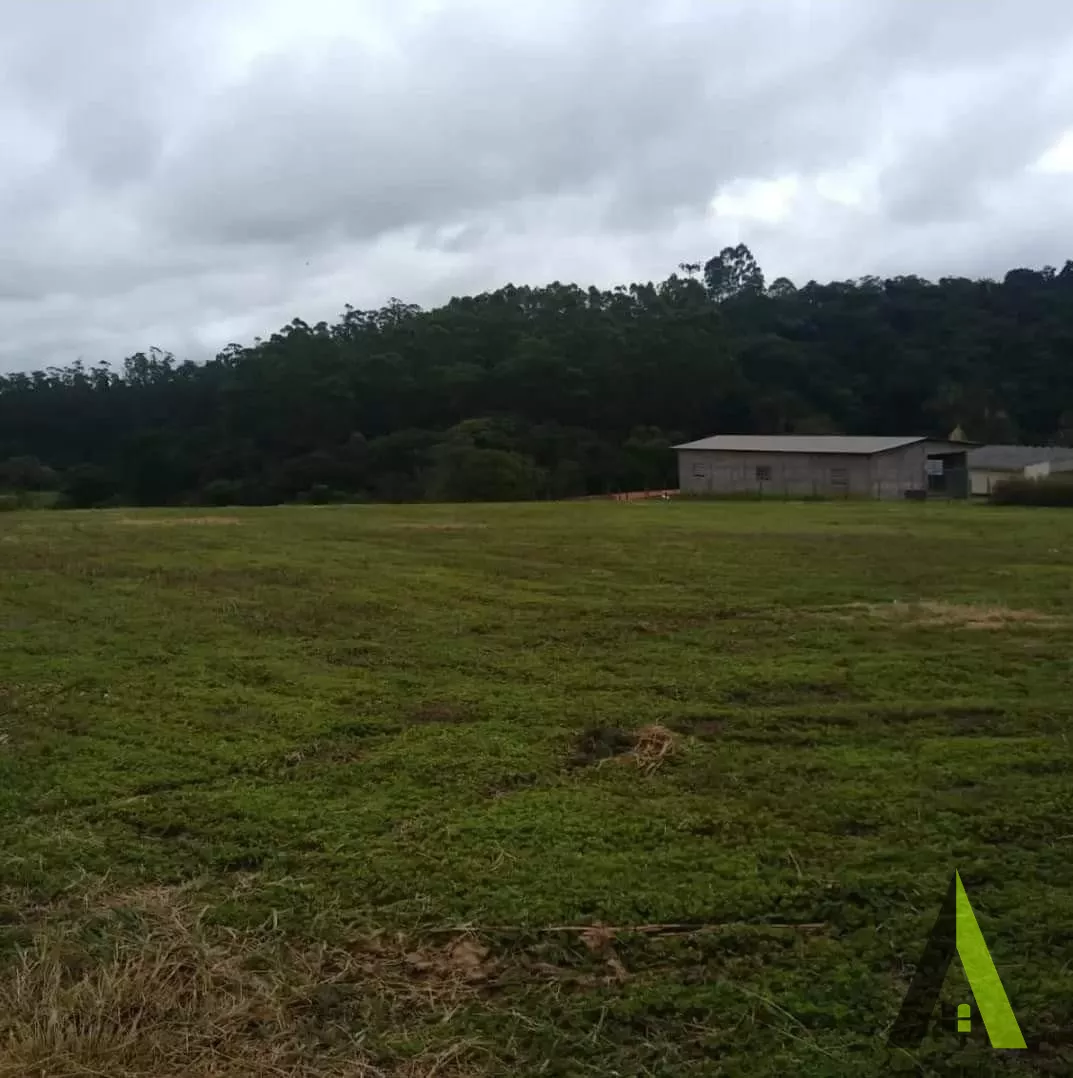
0,501 -> 1073,1078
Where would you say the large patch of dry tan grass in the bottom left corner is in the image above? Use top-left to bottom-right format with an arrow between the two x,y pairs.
0,888 -> 490,1078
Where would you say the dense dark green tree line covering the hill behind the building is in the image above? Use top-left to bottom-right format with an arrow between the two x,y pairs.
0,247 -> 1073,506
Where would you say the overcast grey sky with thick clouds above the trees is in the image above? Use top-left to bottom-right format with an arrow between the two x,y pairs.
0,0 -> 1073,371
